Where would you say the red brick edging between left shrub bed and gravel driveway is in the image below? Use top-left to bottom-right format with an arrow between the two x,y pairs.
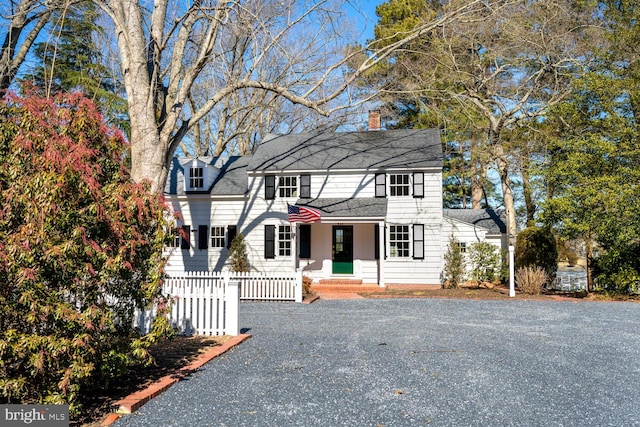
100,334 -> 251,427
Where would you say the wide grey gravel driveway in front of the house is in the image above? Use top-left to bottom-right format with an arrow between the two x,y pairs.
116,299 -> 640,427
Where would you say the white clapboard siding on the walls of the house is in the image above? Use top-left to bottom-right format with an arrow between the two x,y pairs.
167,167 -> 501,284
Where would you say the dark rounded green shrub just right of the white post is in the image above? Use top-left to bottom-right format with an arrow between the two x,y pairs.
515,227 -> 558,280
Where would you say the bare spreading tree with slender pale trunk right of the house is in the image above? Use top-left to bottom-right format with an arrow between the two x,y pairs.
364,0 -> 595,236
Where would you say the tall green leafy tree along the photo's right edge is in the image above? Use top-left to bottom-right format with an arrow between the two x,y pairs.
544,1 -> 640,290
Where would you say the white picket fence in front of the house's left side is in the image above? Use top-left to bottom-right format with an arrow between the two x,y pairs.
135,271 -> 302,335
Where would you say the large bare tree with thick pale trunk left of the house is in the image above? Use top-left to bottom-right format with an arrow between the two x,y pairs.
94,0 -> 487,189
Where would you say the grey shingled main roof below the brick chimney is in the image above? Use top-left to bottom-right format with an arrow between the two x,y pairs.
249,129 -> 442,172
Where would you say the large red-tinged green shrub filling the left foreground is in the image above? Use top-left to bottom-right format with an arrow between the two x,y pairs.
0,95 -> 168,414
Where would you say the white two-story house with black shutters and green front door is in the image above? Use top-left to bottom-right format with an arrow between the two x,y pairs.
165,129 -> 506,286
